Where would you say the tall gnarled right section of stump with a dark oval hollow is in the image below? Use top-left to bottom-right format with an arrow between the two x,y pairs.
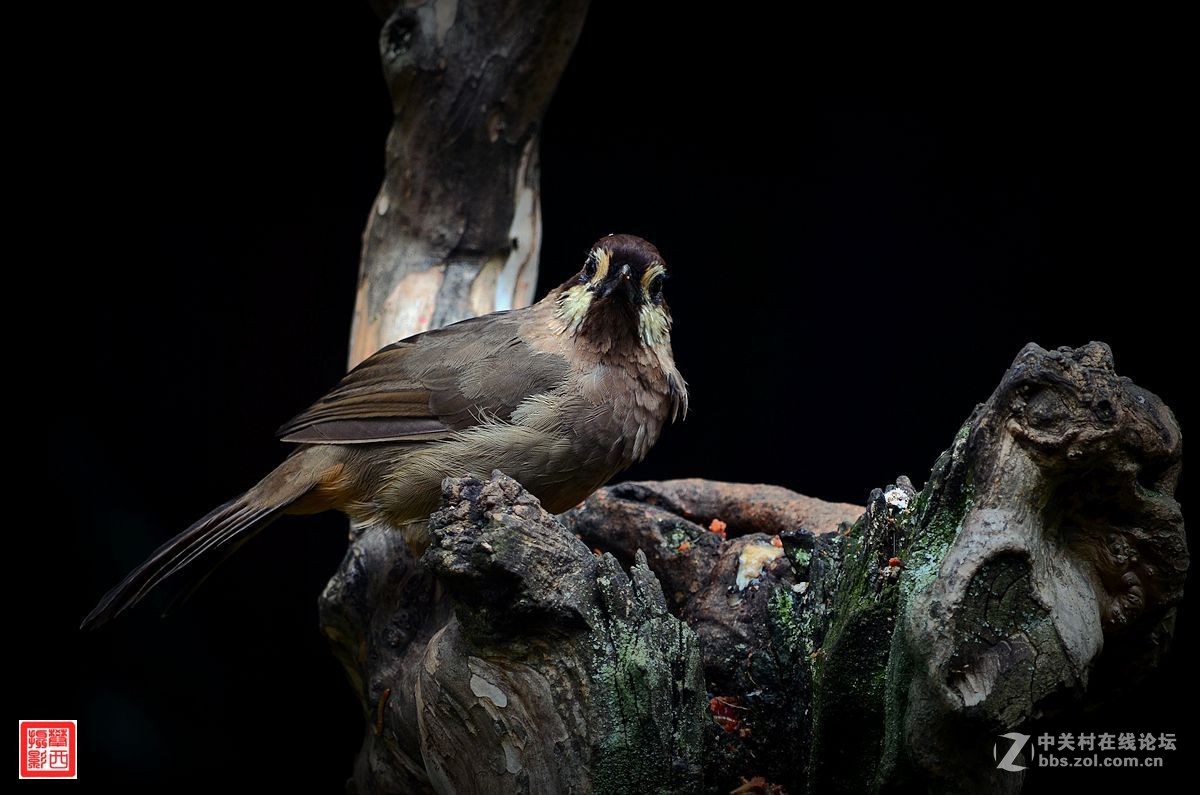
811,342 -> 1188,791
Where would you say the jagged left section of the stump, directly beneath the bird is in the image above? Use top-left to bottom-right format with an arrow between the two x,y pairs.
322,472 -> 706,793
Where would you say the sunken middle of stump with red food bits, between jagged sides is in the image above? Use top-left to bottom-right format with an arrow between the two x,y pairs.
564,479 -> 863,793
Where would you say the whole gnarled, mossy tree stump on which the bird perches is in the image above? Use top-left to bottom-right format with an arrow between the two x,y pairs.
322,343 -> 1188,794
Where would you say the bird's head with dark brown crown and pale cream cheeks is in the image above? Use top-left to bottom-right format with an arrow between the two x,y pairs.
557,234 -> 671,346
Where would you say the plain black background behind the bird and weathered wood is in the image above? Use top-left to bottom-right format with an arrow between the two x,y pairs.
28,2 -> 1196,791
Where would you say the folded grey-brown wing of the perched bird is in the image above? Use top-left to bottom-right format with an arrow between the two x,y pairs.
278,312 -> 570,444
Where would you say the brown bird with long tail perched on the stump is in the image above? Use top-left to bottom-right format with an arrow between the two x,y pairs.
80,234 -> 689,629
